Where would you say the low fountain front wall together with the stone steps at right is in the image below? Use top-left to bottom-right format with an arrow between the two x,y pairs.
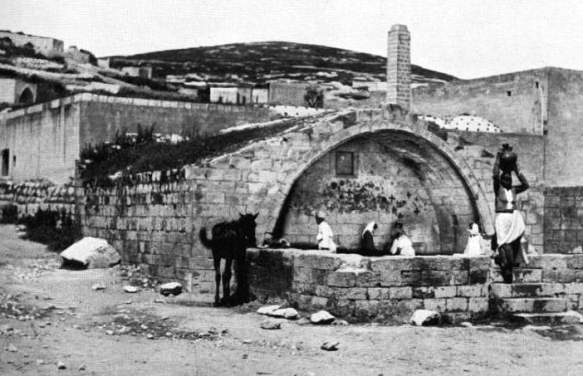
248,249 -> 583,323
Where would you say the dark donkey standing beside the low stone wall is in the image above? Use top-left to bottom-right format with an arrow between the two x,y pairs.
199,213 -> 259,306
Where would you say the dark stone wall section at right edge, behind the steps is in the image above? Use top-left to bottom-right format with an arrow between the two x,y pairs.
544,187 -> 583,253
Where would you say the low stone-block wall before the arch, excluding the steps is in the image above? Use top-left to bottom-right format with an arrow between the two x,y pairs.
248,249 -> 490,322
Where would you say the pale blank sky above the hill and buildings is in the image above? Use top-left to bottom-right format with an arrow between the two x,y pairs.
0,0 -> 583,78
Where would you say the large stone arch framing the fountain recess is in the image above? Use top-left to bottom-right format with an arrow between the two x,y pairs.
211,110 -> 493,251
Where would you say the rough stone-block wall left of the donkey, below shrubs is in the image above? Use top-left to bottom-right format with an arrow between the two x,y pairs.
80,171 -> 211,292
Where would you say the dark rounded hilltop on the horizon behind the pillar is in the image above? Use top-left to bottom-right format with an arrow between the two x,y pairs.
111,42 -> 455,84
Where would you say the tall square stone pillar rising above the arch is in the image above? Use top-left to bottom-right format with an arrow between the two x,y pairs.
387,25 -> 411,112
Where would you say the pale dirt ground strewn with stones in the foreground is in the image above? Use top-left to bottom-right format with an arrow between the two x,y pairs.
0,225 -> 583,376
